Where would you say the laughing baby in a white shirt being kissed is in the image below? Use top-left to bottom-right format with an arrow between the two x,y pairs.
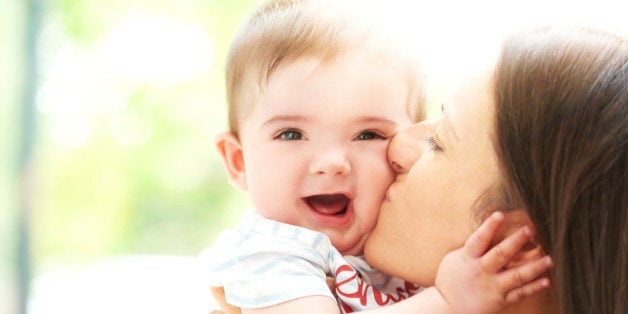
201,1 -> 546,313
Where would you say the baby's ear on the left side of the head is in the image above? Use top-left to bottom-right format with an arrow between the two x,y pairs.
215,132 -> 248,191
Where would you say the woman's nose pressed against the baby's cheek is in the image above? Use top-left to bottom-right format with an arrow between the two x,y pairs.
388,121 -> 433,174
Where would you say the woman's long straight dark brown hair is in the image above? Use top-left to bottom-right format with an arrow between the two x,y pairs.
494,28 -> 628,314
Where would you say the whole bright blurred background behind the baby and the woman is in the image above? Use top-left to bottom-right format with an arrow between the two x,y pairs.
0,0 -> 627,314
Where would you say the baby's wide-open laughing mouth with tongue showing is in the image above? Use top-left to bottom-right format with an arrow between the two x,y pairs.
303,194 -> 351,225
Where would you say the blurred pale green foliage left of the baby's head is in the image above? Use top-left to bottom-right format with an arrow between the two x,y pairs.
0,0 -> 257,278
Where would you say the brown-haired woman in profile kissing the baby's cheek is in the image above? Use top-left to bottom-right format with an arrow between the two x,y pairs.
365,28 -> 628,313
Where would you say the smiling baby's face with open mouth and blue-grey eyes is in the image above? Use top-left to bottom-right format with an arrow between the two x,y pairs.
240,53 -> 411,255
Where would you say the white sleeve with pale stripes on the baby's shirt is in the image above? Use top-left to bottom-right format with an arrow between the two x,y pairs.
200,212 -> 334,308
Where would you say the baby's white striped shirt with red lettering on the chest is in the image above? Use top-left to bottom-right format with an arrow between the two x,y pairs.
200,211 -> 419,312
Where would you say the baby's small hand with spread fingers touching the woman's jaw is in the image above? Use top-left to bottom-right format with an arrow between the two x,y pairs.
435,212 -> 552,313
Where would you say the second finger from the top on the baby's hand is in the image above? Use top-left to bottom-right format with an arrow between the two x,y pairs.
481,226 -> 532,272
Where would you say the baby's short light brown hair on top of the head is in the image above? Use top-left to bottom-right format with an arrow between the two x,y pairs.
226,0 -> 425,135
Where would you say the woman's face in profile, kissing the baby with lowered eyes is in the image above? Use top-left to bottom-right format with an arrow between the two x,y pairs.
365,70 -> 498,286
